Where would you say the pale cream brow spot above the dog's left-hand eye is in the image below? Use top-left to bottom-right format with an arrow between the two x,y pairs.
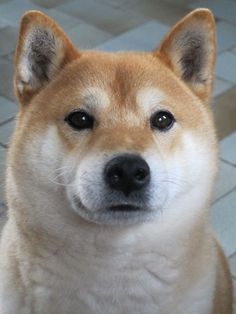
80,87 -> 109,109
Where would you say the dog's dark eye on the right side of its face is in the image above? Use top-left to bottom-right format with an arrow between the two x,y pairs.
151,111 -> 175,131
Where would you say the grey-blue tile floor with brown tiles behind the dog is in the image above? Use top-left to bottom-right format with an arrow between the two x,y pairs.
0,0 -> 236,310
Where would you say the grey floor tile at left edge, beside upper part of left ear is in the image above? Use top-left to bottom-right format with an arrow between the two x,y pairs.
0,25 -> 18,56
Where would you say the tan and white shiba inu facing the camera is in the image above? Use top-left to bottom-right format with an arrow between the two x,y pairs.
0,9 -> 232,314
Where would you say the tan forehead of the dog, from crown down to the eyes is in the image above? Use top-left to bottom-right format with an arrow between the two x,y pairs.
28,52 -> 203,129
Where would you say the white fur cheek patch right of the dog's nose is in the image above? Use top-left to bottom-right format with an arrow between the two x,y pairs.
166,132 -> 216,198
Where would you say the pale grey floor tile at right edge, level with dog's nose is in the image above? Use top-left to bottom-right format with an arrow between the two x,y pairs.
213,161 -> 236,201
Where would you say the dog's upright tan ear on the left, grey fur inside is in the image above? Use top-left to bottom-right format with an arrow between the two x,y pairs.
14,11 -> 79,105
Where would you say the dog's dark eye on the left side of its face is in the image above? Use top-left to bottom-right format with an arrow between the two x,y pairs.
65,111 -> 94,130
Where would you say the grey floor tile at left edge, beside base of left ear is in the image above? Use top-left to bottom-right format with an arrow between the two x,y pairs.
0,58 -> 14,100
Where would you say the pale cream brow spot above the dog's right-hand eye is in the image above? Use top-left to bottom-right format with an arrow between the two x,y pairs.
136,87 -> 165,114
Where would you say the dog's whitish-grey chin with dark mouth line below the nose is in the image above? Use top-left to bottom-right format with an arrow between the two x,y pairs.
72,199 -> 157,226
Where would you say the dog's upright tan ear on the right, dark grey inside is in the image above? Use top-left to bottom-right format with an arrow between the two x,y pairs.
154,9 -> 216,102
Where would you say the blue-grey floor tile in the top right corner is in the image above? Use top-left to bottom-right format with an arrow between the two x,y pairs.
190,0 -> 236,23
